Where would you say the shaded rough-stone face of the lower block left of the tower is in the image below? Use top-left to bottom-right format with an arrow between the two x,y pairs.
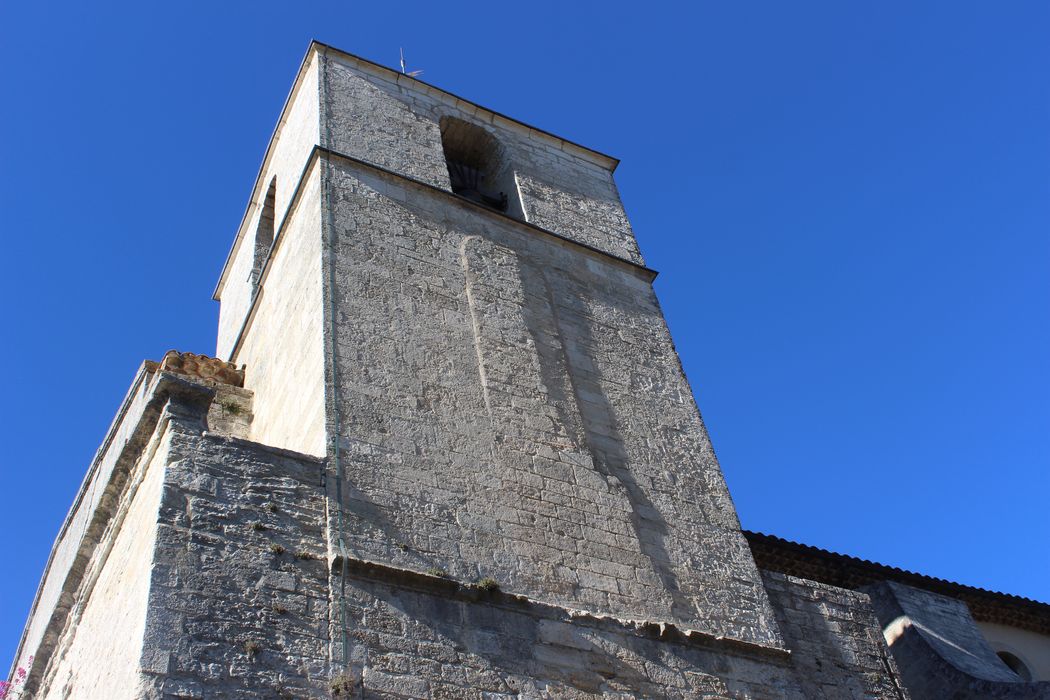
136,424 -> 330,698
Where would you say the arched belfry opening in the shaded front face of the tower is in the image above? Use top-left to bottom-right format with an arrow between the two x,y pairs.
441,116 -> 513,212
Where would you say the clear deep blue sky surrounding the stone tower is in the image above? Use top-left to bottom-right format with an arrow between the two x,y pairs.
0,1 -> 1050,665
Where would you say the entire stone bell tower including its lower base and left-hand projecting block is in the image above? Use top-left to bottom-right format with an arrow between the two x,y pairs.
10,43 -> 911,698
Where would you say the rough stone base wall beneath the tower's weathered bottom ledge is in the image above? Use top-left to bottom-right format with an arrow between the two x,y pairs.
347,578 -> 776,698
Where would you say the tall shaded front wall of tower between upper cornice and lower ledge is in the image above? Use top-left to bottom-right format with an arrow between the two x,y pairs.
326,158 -> 780,646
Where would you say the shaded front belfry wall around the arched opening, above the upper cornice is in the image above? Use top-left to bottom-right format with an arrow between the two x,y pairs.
321,51 -> 642,262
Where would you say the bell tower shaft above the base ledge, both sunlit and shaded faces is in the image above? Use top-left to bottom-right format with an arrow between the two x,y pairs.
216,41 -> 781,646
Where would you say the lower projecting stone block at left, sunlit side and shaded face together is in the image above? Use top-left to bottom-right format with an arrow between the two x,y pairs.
20,377 -> 330,700
